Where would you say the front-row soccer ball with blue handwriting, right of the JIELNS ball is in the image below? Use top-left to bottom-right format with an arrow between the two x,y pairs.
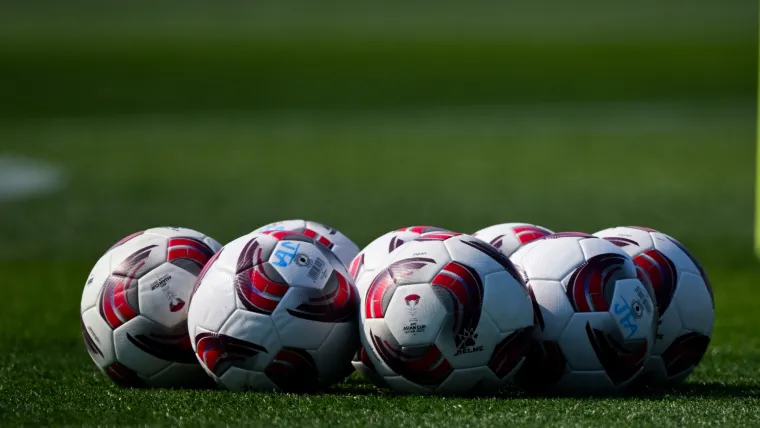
511,232 -> 657,394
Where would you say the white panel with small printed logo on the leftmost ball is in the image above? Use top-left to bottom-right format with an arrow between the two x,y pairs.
138,263 -> 196,328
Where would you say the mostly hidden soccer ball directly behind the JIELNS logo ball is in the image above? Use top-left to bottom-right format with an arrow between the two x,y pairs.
348,226 -> 445,385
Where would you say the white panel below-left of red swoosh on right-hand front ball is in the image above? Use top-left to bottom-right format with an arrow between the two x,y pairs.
528,280 -> 575,340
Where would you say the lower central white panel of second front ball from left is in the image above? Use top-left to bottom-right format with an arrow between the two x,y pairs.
219,310 -> 283,372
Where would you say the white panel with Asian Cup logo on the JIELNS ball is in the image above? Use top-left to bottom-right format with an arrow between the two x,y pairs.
384,284 -> 449,346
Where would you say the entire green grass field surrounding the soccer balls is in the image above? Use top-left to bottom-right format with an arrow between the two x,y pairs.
0,0 -> 760,427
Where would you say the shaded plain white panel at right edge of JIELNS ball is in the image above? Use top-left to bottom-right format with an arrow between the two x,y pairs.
483,271 -> 534,333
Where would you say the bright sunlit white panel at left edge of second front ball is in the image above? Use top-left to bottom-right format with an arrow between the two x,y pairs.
187,264 -> 237,334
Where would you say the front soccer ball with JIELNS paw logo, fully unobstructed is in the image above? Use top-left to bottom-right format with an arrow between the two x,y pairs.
360,232 -> 533,394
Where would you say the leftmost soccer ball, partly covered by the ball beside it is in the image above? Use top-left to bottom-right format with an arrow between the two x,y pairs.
80,227 -> 221,387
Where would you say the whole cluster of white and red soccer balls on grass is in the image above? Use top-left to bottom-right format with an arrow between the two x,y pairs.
81,220 -> 714,394
